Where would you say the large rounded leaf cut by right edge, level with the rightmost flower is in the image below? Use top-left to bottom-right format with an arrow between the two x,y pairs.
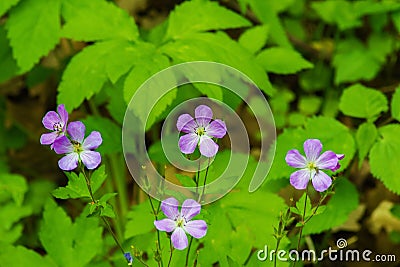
369,124 -> 400,194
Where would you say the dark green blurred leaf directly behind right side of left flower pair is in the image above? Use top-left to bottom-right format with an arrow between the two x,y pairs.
82,116 -> 122,154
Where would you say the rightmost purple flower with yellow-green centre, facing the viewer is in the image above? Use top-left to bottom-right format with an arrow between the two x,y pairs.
285,139 -> 344,192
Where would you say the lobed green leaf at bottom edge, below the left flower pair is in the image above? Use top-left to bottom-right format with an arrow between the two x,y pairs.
39,200 -> 102,267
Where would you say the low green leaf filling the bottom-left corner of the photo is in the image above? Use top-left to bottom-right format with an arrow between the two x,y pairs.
0,246 -> 57,267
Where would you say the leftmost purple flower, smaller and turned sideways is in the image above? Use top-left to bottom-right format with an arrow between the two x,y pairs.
40,105 -> 68,149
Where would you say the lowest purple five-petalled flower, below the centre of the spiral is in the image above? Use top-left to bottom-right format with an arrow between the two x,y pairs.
154,197 -> 207,250
